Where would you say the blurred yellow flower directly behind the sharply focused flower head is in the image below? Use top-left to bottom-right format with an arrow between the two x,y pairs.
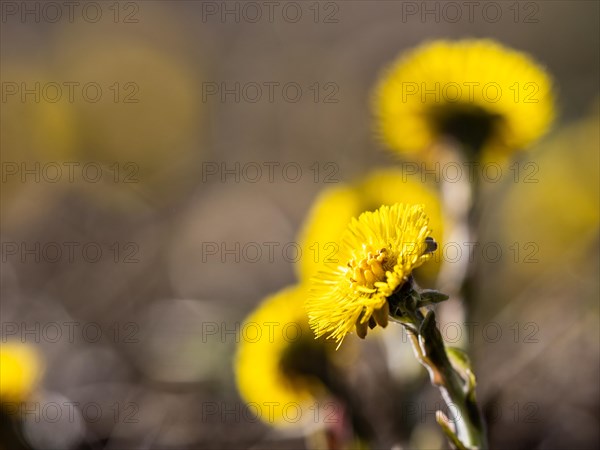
298,169 -> 444,283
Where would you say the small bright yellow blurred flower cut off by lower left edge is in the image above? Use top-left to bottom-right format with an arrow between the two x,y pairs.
0,342 -> 41,402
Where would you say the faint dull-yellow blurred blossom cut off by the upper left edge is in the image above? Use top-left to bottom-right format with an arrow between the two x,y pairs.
0,61 -> 77,228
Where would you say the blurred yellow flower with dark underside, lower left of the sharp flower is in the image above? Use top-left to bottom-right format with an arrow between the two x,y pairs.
235,285 -> 333,427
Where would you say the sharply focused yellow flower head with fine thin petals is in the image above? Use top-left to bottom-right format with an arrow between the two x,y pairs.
306,204 -> 436,347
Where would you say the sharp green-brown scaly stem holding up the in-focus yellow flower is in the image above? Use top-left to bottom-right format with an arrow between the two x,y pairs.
390,290 -> 487,450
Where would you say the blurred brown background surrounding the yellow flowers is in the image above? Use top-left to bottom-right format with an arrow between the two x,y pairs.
0,1 -> 600,449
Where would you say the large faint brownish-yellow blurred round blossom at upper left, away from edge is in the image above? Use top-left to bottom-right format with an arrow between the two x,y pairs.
52,32 -> 204,210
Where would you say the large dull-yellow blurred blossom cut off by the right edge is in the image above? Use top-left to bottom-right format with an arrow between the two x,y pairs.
496,110 -> 600,279
